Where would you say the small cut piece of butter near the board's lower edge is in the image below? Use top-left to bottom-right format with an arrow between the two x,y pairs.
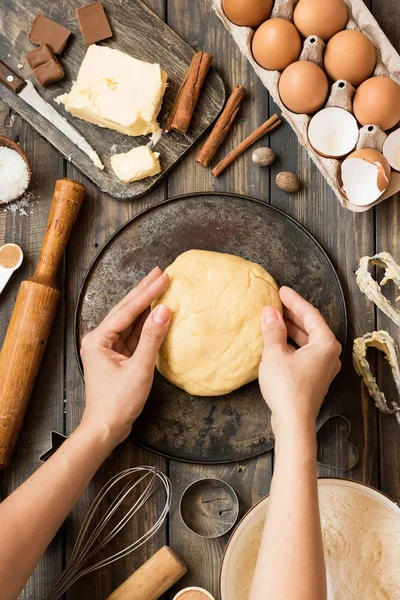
111,146 -> 161,183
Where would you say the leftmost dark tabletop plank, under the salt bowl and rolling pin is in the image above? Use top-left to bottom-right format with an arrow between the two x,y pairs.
0,102 -> 65,600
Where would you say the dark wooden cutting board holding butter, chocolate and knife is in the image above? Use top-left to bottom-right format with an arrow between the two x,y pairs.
0,0 -> 225,200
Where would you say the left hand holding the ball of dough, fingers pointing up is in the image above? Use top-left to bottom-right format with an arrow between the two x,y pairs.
81,267 -> 171,447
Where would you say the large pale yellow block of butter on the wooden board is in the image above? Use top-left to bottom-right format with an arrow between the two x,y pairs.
56,44 -> 168,136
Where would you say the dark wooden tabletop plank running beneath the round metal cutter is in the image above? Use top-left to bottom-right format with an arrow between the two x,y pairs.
168,0 -> 272,598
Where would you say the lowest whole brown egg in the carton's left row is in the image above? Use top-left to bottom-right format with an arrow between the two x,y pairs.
279,60 -> 329,115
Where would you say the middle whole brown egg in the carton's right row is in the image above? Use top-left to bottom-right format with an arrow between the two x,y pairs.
324,29 -> 376,87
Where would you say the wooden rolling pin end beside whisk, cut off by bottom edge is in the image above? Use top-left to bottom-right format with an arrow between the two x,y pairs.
107,546 -> 187,600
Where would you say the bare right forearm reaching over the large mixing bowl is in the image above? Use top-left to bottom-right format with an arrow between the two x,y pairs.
250,422 -> 326,600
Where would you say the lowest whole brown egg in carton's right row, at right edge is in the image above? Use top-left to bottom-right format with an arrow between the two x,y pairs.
353,77 -> 400,131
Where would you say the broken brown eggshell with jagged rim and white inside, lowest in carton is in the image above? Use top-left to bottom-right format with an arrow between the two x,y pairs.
341,148 -> 391,206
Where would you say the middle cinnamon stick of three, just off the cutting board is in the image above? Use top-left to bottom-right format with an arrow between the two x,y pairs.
196,85 -> 246,167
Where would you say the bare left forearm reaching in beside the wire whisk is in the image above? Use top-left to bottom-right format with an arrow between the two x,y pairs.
0,425 -> 112,600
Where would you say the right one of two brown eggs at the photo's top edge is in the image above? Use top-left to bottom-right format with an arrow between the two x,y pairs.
293,0 -> 349,42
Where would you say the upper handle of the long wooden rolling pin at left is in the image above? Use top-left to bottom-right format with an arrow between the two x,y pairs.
30,178 -> 85,287
